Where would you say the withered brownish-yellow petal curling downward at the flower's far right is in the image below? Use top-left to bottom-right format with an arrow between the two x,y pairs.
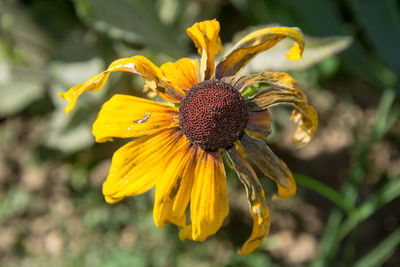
244,72 -> 318,146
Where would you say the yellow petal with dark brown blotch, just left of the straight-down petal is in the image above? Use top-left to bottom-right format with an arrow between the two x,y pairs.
153,144 -> 197,227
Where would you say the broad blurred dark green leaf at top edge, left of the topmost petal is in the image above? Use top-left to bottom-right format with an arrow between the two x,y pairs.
74,0 -> 184,55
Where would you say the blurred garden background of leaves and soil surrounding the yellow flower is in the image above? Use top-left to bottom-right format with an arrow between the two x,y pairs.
0,0 -> 400,267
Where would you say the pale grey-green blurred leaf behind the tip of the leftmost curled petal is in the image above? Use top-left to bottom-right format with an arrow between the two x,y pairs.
43,58 -> 108,153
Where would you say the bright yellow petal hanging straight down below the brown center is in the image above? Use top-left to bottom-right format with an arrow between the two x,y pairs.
179,150 -> 229,241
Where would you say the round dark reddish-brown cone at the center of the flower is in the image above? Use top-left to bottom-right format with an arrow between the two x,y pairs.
179,81 -> 249,151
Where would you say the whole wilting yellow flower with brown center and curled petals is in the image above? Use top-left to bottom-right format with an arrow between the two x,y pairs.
60,20 -> 318,255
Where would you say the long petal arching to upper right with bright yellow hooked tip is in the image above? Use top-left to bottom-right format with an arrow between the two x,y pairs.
215,27 -> 304,82
